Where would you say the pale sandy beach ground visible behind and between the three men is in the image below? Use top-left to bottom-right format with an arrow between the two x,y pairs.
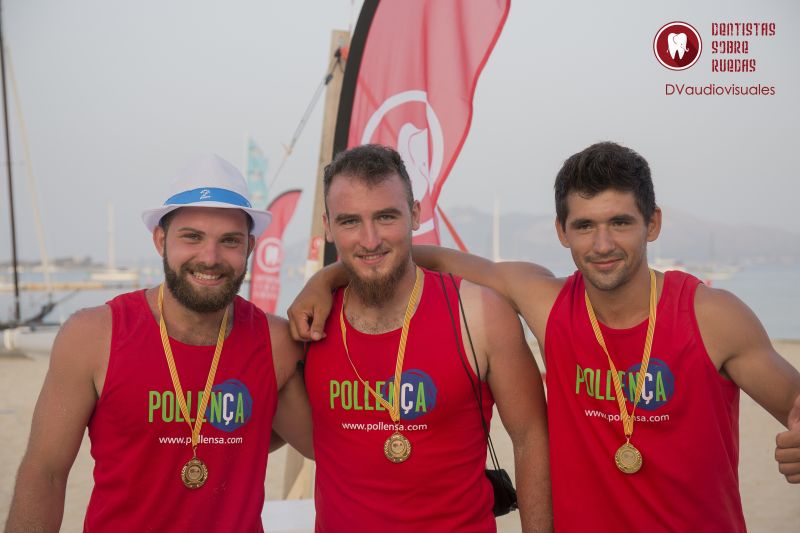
0,341 -> 800,533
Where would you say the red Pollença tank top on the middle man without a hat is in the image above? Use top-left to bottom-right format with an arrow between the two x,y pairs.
305,272 -> 495,533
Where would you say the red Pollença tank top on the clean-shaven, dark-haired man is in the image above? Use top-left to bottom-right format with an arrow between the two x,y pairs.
545,272 -> 745,533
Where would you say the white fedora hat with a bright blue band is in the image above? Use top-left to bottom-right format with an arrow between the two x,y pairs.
142,154 -> 272,237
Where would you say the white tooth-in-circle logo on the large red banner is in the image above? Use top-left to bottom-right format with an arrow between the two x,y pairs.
361,91 -> 444,236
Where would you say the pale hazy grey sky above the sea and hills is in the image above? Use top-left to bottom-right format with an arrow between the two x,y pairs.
0,0 -> 800,266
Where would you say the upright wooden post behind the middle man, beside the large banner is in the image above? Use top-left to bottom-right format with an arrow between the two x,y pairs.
283,30 -> 350,499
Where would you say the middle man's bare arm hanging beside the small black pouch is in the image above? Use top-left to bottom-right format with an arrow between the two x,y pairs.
461,281 -> 552,533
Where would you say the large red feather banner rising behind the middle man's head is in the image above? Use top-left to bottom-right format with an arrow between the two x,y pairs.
334,0 -> 510,244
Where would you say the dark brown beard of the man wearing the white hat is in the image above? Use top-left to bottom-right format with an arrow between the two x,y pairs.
164,248 -> 245,313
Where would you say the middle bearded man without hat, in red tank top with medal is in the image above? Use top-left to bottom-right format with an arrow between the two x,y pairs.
305,146 -> 551,532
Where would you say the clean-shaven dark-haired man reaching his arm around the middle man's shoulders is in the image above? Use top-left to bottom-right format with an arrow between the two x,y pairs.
290,143 -> 800,532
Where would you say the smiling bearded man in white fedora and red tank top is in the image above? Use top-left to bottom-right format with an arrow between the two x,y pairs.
6,156 -> 312,532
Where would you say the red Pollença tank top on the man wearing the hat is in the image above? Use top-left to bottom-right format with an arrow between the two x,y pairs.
84,291 -> 277,532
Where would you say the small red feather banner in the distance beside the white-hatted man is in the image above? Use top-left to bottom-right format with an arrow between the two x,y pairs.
250,190 -> 301,313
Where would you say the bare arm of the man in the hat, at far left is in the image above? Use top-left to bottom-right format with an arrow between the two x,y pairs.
6,306 -> 111,533
